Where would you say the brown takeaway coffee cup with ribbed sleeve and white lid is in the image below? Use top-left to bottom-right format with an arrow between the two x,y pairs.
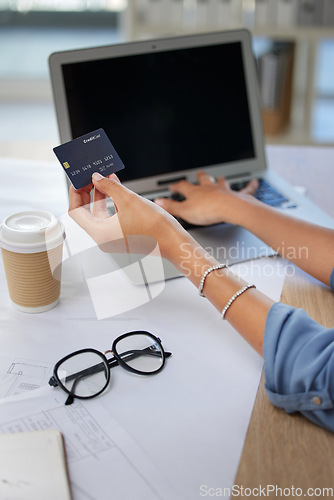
0,211 -> 65,313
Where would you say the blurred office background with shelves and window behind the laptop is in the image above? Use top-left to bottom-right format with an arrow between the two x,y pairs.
0,0 -> 334,159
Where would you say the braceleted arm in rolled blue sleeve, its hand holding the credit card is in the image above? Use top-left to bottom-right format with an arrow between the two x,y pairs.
69,174 -> 334,431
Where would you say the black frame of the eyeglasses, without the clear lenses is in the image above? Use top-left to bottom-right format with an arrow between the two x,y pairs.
49,330 -> 172,405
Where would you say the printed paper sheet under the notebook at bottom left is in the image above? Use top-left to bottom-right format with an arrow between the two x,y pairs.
0,387 -> 178,500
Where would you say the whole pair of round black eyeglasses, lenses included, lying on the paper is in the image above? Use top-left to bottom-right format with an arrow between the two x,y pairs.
49,331 -> 172,405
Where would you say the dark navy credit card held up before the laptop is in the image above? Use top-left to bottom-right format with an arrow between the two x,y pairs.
53,128 -> 124,189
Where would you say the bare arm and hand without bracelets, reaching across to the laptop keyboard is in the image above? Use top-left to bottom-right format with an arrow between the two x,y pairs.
156,172 -> 334,285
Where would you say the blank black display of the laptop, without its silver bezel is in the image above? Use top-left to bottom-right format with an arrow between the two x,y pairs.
62,42 -> 254,181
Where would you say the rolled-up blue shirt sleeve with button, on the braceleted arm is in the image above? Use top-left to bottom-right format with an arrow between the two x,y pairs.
263,300 -> 334,432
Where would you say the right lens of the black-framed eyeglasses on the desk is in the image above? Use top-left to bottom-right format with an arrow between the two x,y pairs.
115,334 -> 164,373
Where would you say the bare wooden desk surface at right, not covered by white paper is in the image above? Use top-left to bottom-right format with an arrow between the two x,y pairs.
235,146 -> 334,498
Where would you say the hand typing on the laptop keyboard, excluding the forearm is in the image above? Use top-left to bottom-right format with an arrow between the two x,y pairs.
155,171 -> 259,225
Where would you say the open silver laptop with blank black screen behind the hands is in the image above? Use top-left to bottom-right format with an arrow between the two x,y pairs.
49,29 -> 332,281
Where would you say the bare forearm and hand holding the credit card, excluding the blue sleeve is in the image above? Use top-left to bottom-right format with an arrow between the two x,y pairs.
69,175 -> 273,354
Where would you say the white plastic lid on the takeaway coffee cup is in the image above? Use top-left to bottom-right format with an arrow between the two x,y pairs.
0,210 -> 65,253
